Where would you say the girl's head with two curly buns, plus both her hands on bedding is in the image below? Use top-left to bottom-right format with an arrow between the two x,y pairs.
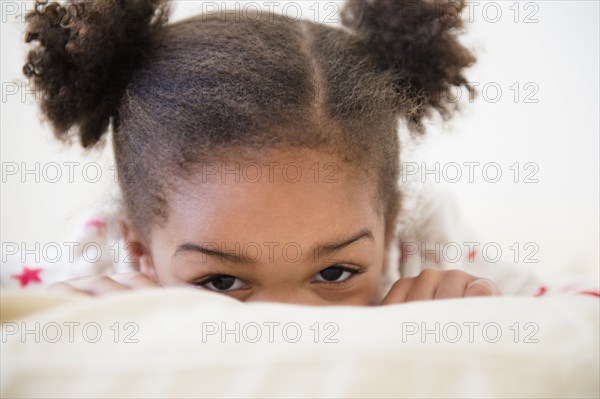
12,0 -> 506,305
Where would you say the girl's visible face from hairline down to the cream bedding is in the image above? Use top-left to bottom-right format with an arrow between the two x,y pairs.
132,150 -> 386,305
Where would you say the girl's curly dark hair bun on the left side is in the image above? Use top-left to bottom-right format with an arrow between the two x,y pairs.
23,0 -> 168,148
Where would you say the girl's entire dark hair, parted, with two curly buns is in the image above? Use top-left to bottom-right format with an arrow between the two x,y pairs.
23,0 -> 475,244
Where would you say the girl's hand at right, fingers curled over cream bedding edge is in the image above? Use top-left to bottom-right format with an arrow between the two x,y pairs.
381,269 -> 502,305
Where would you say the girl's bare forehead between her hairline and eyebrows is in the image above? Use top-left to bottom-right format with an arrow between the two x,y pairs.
165,149 -> 380,241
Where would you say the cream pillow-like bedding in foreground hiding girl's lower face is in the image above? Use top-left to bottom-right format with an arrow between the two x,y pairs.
0,288 -> 600,398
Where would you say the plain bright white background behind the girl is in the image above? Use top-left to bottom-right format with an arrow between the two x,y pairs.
0,0 -> 600,280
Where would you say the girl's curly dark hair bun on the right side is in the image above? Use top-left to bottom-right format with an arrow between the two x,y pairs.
341,0 -> 475,132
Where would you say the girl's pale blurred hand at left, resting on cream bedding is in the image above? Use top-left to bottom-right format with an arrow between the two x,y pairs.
48,272 -> 159,295
